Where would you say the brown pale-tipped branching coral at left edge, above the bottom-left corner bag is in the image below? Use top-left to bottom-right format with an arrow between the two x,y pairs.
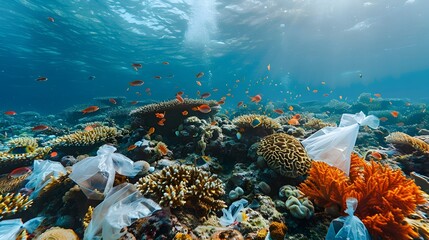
0,193 -> 33,219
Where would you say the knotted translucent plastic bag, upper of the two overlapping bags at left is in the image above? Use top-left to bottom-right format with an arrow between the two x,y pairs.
70,145 -> 143,200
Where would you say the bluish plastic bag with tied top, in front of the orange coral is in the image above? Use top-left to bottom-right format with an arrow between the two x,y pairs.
326,198 -> 371,240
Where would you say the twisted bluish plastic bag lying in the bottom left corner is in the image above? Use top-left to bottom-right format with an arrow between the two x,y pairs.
0,217 -> 45,240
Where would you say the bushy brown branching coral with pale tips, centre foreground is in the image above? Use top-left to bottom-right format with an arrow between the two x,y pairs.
136,165 -> 226,217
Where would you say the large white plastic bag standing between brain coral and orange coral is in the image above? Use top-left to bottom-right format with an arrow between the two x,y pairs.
302,112 -> 380,175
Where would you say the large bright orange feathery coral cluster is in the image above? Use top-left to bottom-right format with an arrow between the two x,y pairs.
300,154 -> 425,239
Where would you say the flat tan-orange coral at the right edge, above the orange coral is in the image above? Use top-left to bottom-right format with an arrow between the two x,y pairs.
386,132 -> 429,154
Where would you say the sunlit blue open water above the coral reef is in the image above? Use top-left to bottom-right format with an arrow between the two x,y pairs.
0,0 -> 429,113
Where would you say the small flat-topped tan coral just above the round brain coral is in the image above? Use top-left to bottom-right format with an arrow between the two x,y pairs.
232,114 -> 281,132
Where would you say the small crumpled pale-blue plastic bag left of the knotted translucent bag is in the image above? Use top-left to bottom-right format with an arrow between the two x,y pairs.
25,160 -> 67,199
